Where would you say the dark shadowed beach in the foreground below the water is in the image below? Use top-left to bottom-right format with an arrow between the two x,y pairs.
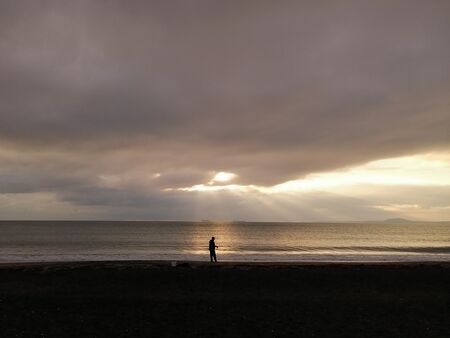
0,261 -> 450,337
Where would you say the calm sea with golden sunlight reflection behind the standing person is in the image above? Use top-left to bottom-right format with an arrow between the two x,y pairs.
0,221 -> 450,263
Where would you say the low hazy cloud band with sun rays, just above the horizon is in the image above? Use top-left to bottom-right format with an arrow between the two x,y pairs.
0,182 -> 450,222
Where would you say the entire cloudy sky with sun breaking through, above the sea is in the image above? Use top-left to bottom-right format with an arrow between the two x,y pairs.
0,0 -> 450,222
